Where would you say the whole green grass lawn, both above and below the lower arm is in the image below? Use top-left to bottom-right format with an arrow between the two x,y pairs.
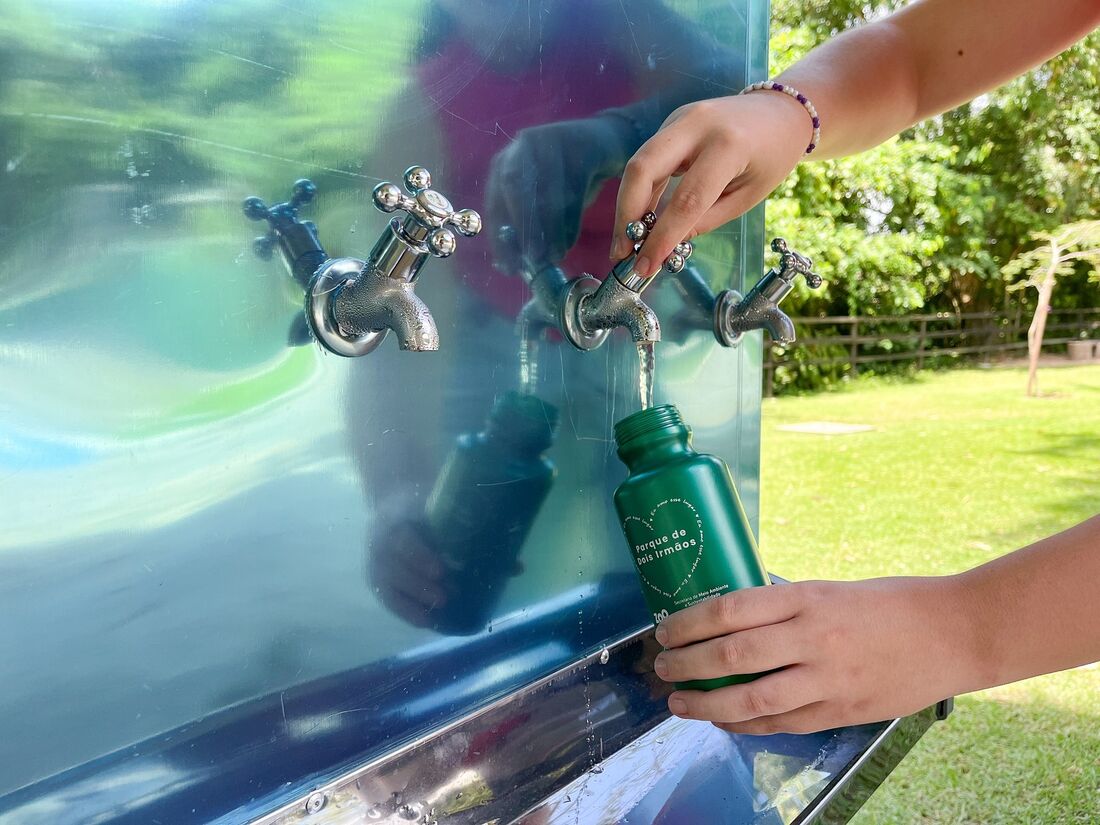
761,366 -> 1100,825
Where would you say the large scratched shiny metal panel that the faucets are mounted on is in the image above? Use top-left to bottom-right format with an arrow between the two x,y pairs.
0,0 -> 767,825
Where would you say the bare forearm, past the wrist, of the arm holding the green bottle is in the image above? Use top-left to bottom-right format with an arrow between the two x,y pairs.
955,516 -> 1100,689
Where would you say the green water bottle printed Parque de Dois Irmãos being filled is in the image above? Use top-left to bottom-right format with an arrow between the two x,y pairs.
615,405 -> 769,691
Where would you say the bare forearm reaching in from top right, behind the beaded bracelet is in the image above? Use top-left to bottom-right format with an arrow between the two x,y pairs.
777,0 -> 1100,157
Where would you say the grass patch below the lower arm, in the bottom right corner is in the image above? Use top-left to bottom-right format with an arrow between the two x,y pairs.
854,689 -> 1100,825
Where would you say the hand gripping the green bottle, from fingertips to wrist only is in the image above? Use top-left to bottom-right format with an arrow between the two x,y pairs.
655,576 -> 981,734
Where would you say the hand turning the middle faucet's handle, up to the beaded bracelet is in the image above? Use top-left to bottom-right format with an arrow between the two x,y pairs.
611,91 -> 813,277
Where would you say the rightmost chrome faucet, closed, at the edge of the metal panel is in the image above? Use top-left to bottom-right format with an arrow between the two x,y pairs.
714,238 -> 822,347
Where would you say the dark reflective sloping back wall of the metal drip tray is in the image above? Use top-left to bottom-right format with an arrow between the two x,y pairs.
245,630 -> 669,825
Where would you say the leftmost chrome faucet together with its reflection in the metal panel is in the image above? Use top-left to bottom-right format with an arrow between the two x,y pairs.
244,166 -> 482,358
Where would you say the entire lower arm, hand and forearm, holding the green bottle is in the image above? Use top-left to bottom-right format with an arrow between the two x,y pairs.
655,516 -> 1100,734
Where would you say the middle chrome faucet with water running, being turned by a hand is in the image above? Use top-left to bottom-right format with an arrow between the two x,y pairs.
561,212 -> 692,350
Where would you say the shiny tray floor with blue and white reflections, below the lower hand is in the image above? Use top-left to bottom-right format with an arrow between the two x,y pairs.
516,708 -> 946,825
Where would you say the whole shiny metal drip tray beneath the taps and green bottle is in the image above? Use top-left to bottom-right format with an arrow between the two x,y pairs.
245,630 -> 934,825
